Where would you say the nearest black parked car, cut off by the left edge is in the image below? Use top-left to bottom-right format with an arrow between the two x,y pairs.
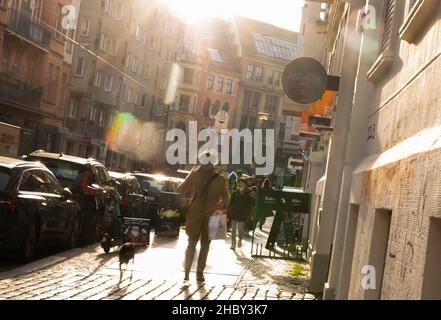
0,157 -> 80,261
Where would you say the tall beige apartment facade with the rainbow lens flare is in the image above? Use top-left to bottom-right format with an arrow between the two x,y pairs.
66,0 -> 159,170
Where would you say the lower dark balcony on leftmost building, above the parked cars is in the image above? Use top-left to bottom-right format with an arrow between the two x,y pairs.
0,73 -> 43,109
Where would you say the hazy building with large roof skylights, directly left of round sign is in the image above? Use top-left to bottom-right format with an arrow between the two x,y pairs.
231,17 -> 302,185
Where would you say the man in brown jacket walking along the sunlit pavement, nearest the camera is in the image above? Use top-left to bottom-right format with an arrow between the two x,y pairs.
177,164 -> 228,282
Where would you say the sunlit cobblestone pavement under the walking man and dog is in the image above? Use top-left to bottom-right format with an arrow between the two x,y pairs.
0,229 -> 314,300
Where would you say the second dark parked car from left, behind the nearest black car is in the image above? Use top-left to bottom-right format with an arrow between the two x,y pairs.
26,150 -> 119,244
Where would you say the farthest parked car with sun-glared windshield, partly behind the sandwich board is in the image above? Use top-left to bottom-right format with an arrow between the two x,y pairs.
134,172 -> 184,226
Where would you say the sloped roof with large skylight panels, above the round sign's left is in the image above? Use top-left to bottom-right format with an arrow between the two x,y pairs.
233,16 -> 299,63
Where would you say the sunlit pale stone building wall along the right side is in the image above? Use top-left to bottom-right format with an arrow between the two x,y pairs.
304,0 -> 441,299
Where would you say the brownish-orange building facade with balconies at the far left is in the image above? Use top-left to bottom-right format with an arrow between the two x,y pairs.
0,0 -> 74,154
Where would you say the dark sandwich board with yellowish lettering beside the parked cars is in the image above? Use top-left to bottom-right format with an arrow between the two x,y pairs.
155,192 -> 181,237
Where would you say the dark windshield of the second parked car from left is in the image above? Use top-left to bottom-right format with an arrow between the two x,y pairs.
31,159 -> 84,188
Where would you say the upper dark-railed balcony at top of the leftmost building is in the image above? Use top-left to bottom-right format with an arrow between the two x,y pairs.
6,8 -> 51,49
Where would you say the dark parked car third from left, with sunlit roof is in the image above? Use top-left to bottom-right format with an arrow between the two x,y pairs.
109,172 -> 150,219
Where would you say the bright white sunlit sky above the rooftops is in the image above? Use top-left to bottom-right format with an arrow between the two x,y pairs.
164,0 -> 304,32
